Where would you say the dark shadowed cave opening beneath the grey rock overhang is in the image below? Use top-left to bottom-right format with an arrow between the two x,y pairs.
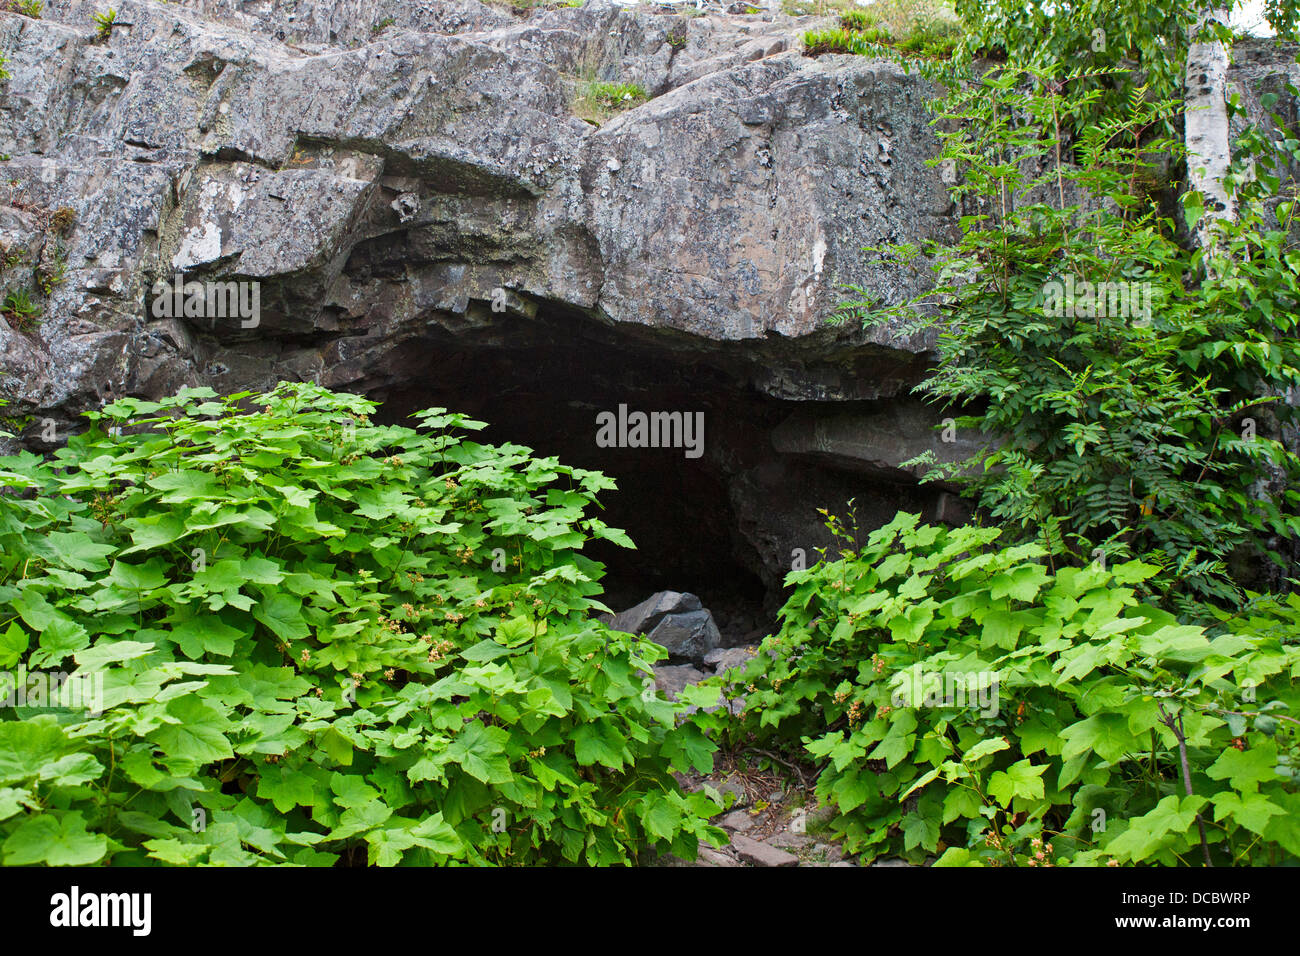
369,310 -> 946,645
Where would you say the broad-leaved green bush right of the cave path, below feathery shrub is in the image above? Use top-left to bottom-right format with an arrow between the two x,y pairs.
696,515 -> 1300,866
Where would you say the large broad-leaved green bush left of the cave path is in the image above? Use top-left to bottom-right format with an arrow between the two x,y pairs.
0,385 -> 722,865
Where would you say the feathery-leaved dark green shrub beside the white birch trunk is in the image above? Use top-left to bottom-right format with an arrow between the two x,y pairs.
846,70 -> 1300,615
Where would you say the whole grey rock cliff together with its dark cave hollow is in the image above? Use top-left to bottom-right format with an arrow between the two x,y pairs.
0,0 -> 1294,606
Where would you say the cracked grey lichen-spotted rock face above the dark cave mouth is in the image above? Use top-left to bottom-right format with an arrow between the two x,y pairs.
0,0 -> 956,429
